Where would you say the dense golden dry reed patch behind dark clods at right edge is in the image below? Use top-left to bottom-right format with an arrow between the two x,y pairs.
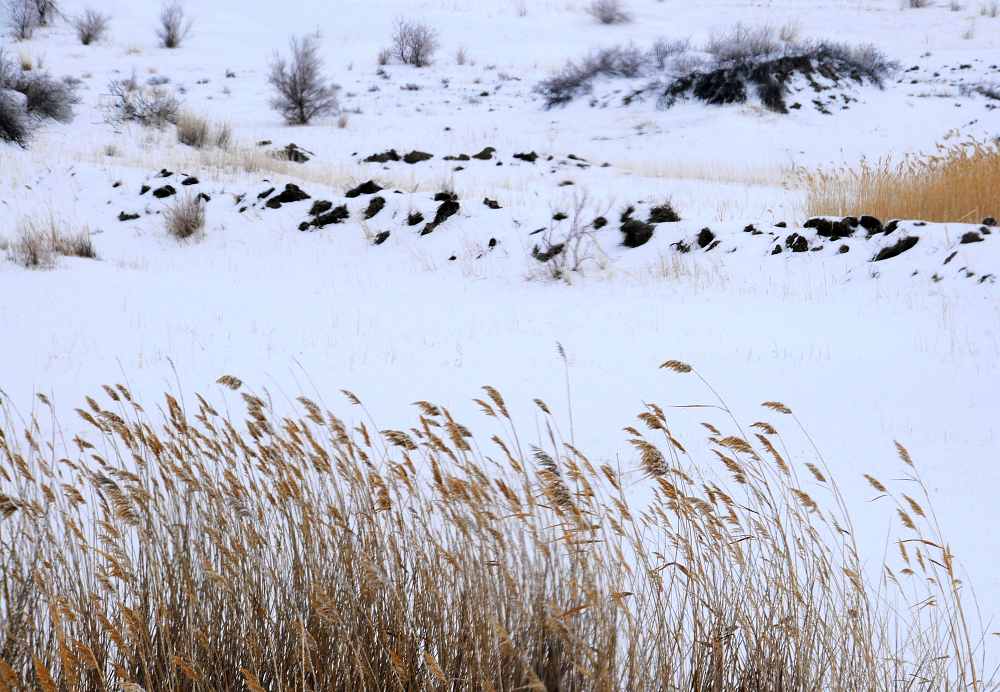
800,141 -> 1000,223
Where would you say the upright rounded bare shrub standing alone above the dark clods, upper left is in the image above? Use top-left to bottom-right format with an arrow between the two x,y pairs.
267,36 -> 339,125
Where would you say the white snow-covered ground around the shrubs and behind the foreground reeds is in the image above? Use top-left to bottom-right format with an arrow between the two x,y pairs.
0,0 -> 1000,660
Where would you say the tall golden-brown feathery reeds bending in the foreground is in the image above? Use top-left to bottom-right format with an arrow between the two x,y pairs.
0,361 -> 985,692
